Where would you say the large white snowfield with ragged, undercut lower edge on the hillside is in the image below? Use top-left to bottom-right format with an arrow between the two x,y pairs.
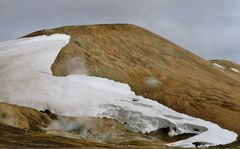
0,34 -> 237,147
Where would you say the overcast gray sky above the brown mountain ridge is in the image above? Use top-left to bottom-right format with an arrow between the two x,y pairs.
0,0 -> 240,63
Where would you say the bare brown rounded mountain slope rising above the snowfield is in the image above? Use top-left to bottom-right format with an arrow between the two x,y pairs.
25,24 -> 240,133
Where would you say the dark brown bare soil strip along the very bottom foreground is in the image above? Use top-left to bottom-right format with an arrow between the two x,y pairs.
0,123 -> 240,149
